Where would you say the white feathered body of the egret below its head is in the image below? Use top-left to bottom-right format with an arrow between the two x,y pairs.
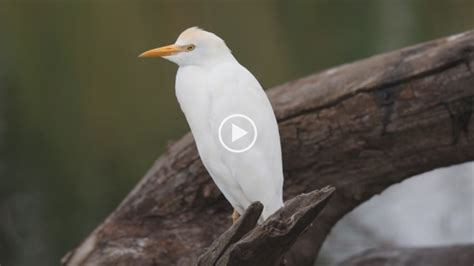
176,58 -> 283,219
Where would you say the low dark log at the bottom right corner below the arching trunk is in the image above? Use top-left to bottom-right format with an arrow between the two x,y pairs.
340,244 -> 474,266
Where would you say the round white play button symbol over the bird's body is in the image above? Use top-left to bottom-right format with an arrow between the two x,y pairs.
218,114 -> 257,153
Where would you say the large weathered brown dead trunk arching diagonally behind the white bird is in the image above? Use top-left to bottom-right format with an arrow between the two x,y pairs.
64,31 -> 474,265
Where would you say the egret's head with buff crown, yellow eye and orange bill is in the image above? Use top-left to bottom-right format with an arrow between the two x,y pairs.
139,27 -> 232,66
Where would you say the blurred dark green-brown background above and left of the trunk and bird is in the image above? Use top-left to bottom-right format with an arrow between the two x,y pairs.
0,0 -> 474,266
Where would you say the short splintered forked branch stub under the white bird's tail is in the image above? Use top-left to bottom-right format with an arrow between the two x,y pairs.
197,187 -> 334,266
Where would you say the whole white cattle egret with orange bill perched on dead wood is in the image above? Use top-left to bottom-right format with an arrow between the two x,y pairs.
140,27 -> 283,222
